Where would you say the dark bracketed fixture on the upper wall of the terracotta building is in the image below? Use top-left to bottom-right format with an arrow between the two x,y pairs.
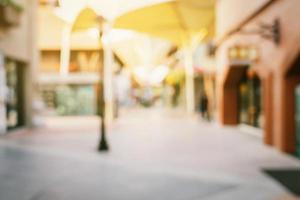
238,18 -> 281,45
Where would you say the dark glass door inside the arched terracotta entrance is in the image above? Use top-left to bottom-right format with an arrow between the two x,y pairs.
238,70 -> 262,128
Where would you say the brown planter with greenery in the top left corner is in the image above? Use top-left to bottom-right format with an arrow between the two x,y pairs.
0,0 -> 23,27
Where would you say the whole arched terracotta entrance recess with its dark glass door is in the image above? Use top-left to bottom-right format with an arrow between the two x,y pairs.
220,64 -> 267,129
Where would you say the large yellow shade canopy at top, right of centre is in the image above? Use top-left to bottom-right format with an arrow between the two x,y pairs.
114,0 -> 215,45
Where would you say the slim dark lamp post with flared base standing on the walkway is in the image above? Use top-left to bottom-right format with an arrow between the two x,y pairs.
98,18 -> 109,152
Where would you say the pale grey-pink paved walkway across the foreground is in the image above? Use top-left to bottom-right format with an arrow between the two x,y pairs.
0,110 -> 300,200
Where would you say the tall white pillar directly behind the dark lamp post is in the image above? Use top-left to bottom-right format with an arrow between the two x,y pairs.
102,24 -> 114,122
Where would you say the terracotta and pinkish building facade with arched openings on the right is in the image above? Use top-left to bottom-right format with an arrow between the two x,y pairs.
216,0 -> 300,153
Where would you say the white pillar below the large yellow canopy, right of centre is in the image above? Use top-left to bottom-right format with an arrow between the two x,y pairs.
184,47 -> 195,114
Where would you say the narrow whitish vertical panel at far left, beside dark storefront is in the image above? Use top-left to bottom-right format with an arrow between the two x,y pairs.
0,53 -> 6,134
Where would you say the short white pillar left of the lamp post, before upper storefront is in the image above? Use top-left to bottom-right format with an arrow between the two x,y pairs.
60,24 -> 72,76
